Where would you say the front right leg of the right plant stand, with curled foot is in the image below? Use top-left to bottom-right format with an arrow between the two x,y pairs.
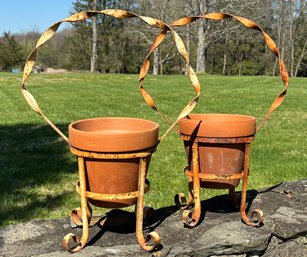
240,143 -> 264,227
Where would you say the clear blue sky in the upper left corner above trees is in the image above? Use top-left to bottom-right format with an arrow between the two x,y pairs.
0,0 -> 73,36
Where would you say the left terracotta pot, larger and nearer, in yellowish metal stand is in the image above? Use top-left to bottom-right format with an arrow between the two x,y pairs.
69,117 -> 159,208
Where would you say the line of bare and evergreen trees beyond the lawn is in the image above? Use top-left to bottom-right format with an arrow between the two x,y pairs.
0,0 -> 307,77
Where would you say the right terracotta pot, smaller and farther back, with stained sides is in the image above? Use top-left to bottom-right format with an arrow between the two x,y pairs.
179,114 -> 256,189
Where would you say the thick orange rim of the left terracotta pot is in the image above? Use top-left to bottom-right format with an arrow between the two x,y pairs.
68,117 -> 159,153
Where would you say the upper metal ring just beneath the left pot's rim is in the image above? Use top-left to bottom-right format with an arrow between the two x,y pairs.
70,146 -> 156,159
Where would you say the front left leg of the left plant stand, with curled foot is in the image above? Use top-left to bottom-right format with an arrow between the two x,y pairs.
63,156 -> 89,253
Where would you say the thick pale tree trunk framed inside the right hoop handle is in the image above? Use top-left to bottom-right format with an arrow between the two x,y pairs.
196,21 -> 206,73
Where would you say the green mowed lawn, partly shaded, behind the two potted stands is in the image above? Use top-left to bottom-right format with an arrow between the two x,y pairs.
0,73 -> 307,226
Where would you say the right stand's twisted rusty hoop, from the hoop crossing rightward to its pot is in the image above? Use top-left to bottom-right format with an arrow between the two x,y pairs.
171,12 -> 289,132
